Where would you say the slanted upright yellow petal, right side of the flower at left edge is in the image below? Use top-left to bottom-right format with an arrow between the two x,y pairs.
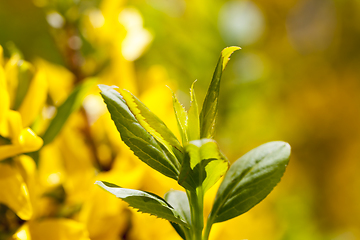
19,71 -> 48,127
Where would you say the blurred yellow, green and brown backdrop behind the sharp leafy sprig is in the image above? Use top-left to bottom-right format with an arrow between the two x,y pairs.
0,0 -> 360,240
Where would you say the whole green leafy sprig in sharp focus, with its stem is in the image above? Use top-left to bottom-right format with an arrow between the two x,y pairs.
96,47 -> 290,240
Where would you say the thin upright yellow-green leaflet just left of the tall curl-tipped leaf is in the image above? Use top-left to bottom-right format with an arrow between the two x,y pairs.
187,81 -> 200,141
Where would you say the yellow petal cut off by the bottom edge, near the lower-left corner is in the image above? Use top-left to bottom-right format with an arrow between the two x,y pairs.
13,219 -> 90,240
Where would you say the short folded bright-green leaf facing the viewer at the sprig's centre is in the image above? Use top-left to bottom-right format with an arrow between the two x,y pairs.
178,139 -> 229,193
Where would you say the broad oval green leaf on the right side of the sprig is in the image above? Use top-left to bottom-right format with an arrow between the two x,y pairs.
209,141 -> 290,224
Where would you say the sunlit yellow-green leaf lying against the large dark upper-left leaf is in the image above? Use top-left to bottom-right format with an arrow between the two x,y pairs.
119,90 -> 183,169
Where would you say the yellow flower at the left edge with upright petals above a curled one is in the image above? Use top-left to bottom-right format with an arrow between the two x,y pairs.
0,46 -> 47,160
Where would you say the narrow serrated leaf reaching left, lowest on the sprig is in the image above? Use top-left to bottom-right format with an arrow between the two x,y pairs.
95,181 -> 189,228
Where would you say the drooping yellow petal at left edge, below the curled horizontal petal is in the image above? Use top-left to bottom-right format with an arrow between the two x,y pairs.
0,164 -> 33,220
